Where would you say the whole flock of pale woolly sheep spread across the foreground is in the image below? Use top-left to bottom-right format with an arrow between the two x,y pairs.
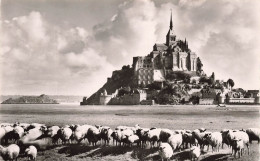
0,122 -> 260,160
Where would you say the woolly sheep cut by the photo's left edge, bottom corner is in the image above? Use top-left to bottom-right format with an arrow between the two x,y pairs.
0,144 -> 20,160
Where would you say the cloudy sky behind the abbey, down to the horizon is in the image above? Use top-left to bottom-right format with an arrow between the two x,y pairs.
0,0 -> 260,96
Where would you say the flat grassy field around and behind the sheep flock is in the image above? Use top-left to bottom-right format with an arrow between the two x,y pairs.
0,105 -> 260,161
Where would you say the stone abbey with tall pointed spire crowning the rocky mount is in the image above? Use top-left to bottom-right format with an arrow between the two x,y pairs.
133,12 -> 197,85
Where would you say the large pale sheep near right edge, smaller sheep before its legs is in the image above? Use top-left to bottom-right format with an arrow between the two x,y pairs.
227,130 -> 249,155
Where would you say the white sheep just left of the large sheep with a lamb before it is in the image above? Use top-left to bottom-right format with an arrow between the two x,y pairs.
204,132 -> 223,153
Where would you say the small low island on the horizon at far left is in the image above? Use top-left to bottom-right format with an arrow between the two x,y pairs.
1,94 -> 59,104
